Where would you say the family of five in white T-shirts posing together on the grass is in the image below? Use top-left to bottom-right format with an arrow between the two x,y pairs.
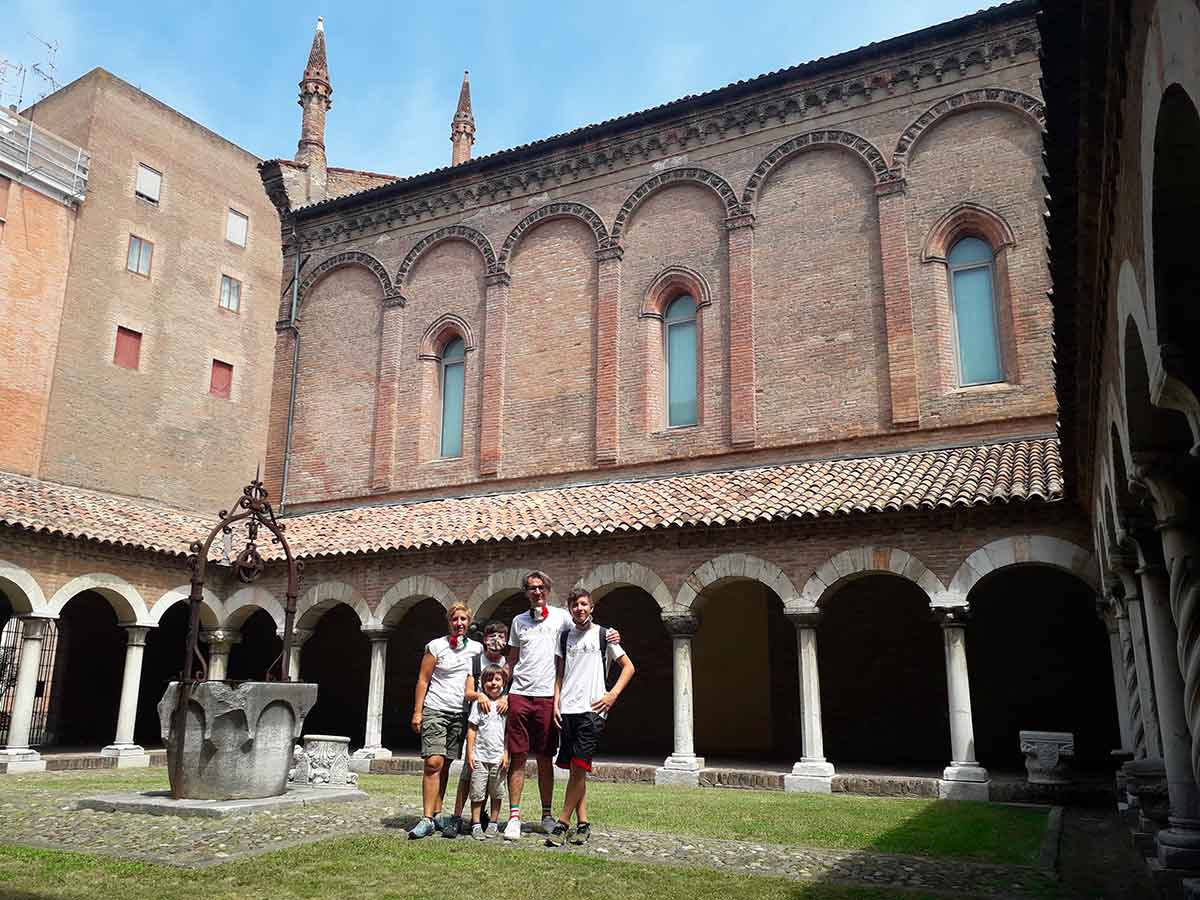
408,571 -> 634,846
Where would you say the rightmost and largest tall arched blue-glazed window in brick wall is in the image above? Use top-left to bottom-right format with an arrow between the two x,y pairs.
947,238 -> 1004,385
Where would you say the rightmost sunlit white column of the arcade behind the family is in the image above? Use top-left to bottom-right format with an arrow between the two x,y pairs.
936,606 -> 991,800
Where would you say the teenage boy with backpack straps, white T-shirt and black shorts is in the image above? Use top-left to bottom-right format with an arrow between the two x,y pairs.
546,589 -> 634,847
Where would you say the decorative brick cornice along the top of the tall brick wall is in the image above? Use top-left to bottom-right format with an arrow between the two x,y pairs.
292,20 -> 1038,251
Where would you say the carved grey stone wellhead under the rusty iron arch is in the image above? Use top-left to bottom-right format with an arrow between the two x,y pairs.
158,682 -> 317,800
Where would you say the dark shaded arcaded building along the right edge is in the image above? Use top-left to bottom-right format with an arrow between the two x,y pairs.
1042,0 -> 1200,896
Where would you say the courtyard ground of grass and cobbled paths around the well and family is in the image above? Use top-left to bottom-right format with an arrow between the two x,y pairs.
0,767 -> 1142,900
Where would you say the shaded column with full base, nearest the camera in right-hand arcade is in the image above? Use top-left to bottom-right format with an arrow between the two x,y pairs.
1136,540 -> 1200,869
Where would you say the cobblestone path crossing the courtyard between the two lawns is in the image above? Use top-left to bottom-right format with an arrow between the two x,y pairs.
0,773 -> 1052,896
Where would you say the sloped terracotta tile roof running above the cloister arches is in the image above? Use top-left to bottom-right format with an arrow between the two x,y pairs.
0,438 -> 1062,557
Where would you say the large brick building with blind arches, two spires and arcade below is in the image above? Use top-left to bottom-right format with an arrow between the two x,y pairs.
0,1 -> 1120,797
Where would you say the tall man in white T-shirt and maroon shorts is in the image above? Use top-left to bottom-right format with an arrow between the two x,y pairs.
504,571 -> 620,841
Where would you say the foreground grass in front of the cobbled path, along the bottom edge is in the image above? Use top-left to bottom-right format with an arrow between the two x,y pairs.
0,836 -> 974,900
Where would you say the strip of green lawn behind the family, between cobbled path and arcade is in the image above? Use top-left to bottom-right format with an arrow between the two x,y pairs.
362,775 -> 1048,865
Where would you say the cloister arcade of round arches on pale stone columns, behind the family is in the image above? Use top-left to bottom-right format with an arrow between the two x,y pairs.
0,535 -> 1121,797
